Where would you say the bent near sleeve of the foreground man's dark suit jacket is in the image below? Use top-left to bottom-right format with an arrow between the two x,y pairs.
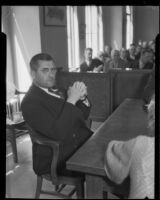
22,98 -> 84,141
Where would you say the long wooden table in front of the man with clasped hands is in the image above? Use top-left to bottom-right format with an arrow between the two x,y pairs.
67,99 -> 148,199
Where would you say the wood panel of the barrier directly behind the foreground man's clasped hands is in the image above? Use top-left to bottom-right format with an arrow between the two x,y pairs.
57,72 -> 111,121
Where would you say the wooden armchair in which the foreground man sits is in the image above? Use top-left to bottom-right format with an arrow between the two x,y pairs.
27,124 -> 84,199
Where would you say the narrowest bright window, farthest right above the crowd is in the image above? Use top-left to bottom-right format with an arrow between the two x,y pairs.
125,6 -> 133,49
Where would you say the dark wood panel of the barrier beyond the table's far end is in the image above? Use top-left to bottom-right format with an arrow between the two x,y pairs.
112,70 -> 151,111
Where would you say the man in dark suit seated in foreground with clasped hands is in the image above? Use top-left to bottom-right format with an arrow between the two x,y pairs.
21,53 -> 92,174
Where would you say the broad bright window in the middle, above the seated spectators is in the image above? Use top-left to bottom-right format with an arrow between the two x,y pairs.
85,6 -> 103,57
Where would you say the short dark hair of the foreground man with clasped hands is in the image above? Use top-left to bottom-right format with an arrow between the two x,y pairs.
29,53 -> 54,71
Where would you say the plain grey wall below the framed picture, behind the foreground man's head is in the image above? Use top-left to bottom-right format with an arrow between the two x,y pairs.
40,6 -> 68,71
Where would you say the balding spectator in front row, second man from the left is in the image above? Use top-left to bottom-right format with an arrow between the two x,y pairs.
104,50 -> 126,72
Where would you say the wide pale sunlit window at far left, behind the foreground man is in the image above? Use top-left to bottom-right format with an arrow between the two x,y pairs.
3,6 -> 41,91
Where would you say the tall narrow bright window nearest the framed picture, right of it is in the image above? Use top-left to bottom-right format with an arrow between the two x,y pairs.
67,6 -> 80,71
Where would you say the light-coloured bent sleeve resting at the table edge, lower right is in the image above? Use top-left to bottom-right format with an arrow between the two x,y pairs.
104,139 -> 135,184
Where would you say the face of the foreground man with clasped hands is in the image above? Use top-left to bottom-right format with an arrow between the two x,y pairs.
32,60 -> 57,88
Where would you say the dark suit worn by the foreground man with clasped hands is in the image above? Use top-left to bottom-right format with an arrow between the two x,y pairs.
21,84 -> 92,174
